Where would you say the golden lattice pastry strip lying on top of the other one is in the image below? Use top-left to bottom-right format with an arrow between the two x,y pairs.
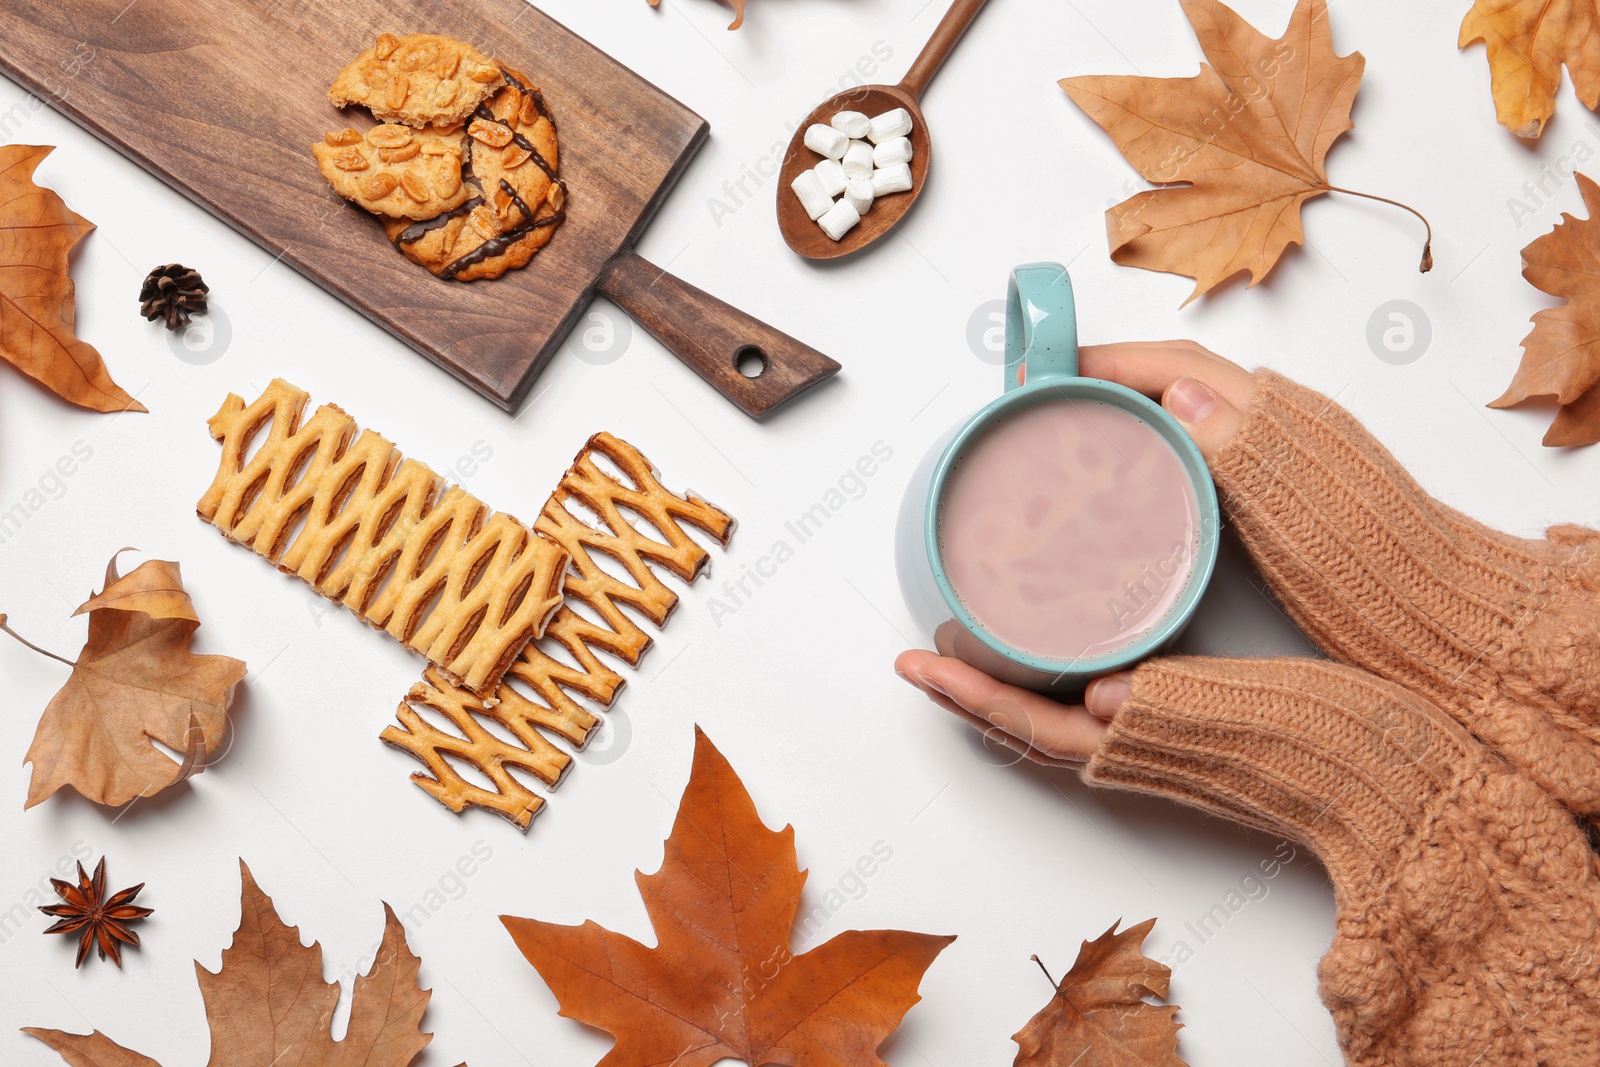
197,379 -> 568,694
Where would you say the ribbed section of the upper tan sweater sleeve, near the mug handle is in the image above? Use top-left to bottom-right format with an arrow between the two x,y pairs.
1211,371 -> 1547,705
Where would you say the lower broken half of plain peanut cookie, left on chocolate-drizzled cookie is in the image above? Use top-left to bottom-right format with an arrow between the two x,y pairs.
310,123 -> 474,219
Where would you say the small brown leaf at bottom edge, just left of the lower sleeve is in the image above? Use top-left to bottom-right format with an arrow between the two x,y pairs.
1011,918 -> 1184,1067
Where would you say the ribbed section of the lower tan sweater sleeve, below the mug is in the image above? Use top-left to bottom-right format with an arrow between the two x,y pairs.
1085,657 -> 1482,893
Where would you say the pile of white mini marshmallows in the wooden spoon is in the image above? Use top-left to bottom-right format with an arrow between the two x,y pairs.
789,107 -> 912,242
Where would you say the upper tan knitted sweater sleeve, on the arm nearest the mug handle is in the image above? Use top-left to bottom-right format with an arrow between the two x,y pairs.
1211,371 -> 1600,816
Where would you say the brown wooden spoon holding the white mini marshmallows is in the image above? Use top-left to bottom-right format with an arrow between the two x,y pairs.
778,0 -> 989,259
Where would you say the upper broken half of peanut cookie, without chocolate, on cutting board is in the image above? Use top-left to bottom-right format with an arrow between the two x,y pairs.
328,34 -> 504,126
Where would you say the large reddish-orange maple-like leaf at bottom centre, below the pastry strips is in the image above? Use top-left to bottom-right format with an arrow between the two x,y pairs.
501,728 -> 955,1067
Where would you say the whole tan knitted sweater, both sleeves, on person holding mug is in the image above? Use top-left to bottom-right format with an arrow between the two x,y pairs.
1086,373 -> 1600,1067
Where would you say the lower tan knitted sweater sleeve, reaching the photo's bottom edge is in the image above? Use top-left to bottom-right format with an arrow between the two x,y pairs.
1085,659 -> 1600,1067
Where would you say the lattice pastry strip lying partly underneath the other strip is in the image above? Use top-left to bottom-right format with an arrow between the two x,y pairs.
382,434 -> 733,830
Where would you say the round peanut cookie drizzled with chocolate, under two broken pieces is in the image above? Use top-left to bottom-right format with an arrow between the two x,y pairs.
386,67 -> 566,282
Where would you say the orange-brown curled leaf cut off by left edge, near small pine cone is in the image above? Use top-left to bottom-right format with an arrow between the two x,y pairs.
0,144 -> 146,411
